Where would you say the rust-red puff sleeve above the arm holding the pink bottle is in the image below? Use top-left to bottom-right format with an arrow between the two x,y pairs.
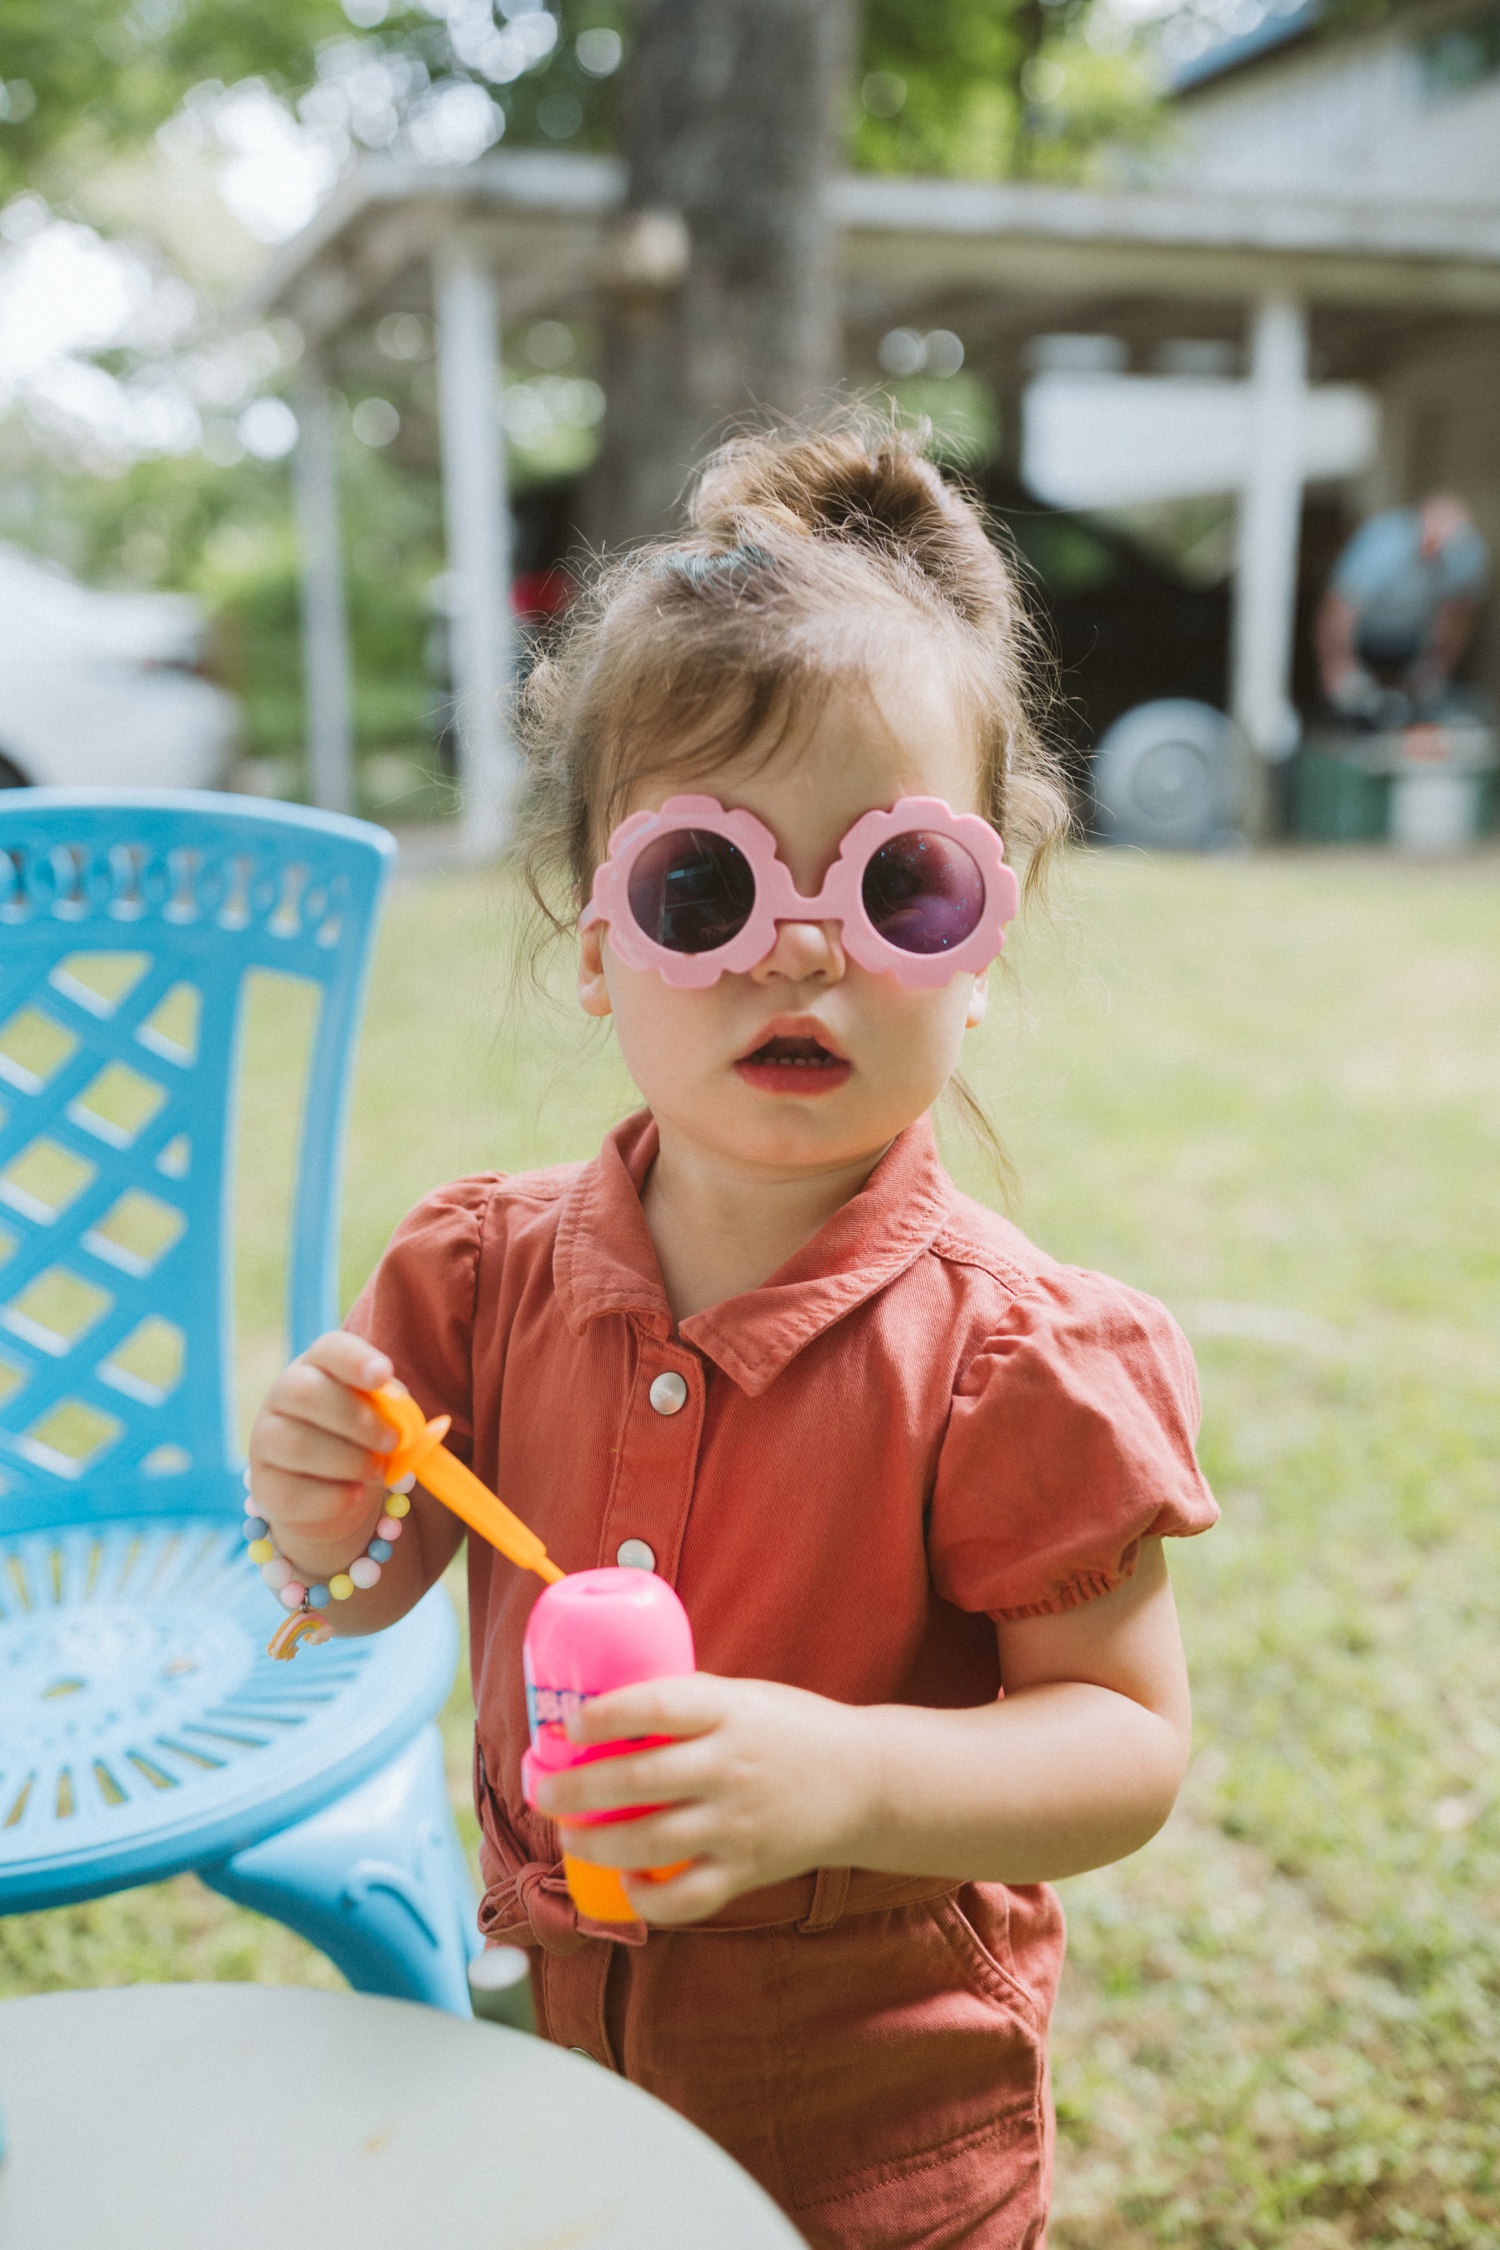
929,1267 -> 1219,1620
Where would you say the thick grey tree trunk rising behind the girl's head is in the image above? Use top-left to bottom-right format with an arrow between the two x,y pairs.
587,0 -> 857,547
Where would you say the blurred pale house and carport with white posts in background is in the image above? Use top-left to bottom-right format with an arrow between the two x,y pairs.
259,0 -> 1500,853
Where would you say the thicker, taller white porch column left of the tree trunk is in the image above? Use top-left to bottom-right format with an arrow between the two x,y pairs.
432,230 -> 517,860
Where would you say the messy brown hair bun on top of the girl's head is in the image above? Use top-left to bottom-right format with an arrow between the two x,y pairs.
693,428 -> 1019,630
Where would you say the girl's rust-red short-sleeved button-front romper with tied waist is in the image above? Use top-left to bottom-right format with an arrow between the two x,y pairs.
349,1114 -> 1217,2250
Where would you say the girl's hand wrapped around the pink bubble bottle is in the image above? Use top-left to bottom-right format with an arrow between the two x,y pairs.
537,1672 -> 870,1924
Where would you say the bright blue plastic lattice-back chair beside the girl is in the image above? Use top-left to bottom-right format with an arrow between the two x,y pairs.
0,790 -> 479,2014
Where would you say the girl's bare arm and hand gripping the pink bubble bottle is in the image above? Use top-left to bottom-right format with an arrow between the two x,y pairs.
537,1539 -> 1192,1922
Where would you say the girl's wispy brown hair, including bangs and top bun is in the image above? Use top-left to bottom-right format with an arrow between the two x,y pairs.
519,419 -> 1068,927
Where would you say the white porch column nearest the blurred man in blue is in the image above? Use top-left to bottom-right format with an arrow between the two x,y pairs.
1230,297 -> 1307,758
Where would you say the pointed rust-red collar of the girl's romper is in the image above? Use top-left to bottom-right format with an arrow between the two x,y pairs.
553,1109 -> 951,1397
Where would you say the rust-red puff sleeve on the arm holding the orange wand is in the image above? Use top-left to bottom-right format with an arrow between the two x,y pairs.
344,1179 -> 497,1463
